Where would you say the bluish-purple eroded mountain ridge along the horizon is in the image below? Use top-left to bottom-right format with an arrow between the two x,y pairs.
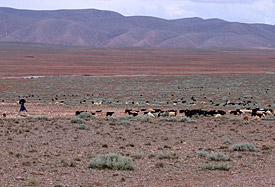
0,8 -> 275,48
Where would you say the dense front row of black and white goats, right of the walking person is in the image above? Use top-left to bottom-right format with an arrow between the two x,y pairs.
75,108 -> 275,118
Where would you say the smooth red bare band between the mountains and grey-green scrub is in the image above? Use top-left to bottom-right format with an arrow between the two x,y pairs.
0,48 -> 275,78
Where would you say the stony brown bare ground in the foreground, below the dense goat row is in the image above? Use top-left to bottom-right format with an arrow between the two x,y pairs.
0,104 -> 275,187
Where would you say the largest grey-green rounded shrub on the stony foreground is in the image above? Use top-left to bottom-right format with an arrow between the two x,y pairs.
89,153 -> 135,170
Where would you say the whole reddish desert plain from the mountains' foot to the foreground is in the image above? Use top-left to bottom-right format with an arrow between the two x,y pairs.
0,45 -> 275,187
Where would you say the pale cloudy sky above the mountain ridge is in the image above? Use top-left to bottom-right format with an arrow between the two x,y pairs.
0,0 -> 275,25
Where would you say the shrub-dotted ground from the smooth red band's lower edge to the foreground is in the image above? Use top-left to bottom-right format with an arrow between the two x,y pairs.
0,75 -> 275,186
